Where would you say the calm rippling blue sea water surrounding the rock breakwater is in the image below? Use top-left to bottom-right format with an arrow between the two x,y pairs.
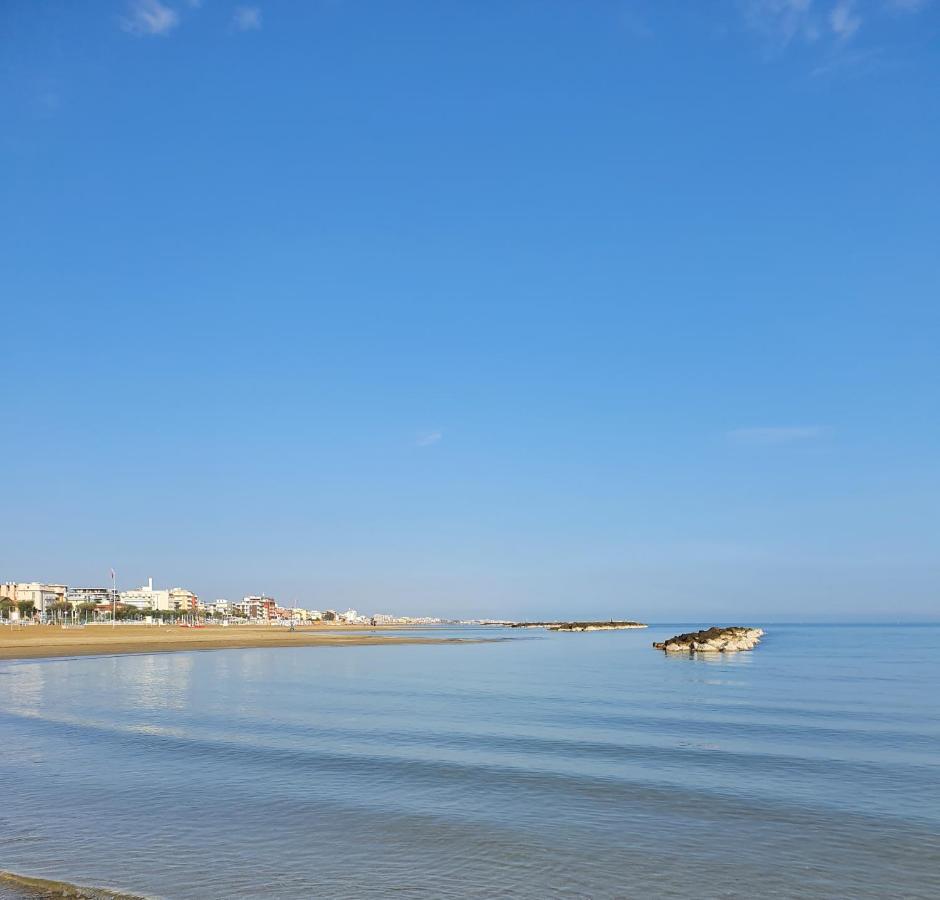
0,626 -> 940,898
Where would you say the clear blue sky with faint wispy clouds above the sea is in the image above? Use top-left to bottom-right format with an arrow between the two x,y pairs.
0,0 -> 940,624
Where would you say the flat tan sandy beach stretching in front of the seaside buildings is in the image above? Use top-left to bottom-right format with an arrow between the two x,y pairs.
0,624 -> 485,659
